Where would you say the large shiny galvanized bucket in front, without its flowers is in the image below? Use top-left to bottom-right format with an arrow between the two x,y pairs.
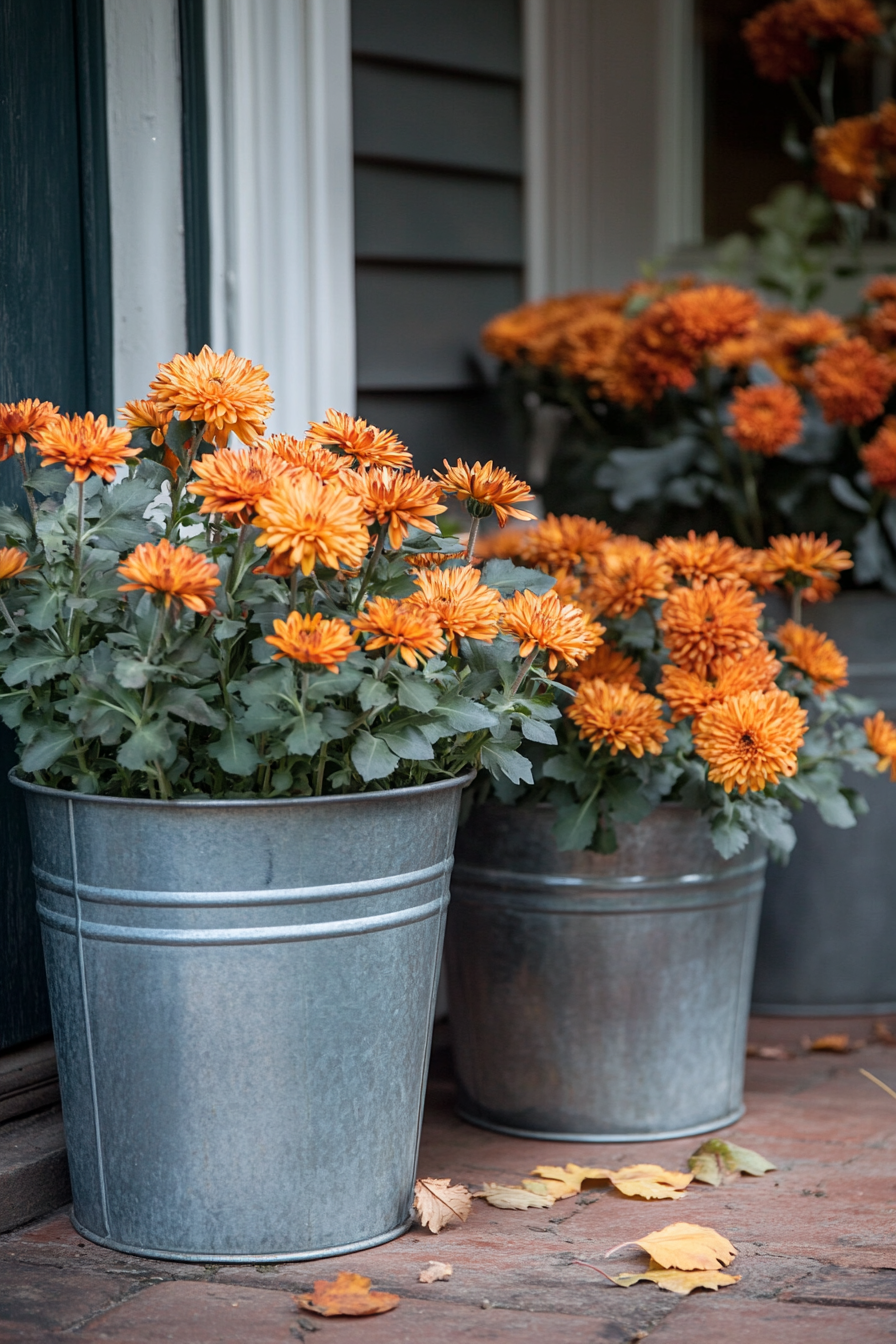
16,777 -> 469,1261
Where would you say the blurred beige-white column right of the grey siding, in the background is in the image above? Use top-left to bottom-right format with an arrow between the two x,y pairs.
524,0 -> 700,298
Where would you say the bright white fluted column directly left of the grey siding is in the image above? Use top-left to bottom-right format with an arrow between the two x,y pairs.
206,0 -> 355,434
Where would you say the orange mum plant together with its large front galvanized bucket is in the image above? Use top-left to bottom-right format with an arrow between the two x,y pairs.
0,348 -> 598,1261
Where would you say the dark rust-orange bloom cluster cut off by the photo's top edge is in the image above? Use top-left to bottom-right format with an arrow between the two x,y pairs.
742,0 -> 883,83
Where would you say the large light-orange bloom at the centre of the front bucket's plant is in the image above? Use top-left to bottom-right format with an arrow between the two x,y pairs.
254,470 -> 371,574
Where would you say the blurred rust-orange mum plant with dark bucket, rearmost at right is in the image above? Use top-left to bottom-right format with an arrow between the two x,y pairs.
486,276 -> 896,1013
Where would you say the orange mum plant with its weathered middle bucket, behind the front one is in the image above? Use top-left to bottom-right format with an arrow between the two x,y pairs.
447,516 -> 896,1141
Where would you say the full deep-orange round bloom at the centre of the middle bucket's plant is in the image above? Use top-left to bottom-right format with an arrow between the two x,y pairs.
657,579 -> 763,677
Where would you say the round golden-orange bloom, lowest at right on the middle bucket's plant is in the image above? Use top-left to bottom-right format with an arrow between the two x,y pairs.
693,691 -> 806,793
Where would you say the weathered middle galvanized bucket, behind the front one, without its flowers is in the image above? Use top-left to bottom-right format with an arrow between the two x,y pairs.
446,804 -> 766,1142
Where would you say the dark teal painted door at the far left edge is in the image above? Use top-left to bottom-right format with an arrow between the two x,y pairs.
0,0 -> 113,1050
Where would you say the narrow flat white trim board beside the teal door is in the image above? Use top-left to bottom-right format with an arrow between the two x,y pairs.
103,0 -> 187,406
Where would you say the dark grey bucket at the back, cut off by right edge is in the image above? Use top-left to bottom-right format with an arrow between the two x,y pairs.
754,593 -> 896,1016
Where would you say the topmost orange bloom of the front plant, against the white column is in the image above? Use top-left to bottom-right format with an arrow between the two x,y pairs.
149,345 -> 274,448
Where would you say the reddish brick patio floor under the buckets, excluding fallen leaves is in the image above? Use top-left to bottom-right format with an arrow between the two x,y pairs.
0,1017 -> 896,1344
